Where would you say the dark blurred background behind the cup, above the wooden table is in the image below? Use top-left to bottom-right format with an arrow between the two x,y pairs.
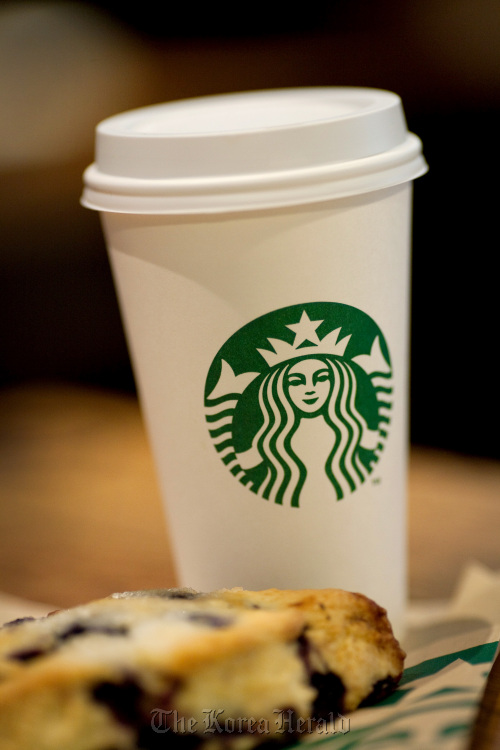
0,0 -> 500,458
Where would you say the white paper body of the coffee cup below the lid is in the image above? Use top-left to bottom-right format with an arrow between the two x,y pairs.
83,86 -> 426,630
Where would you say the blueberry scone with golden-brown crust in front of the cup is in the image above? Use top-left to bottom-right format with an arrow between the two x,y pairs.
0,589 -> 404,750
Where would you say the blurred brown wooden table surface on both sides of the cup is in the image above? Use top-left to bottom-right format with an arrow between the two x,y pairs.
0,385 -> 500,606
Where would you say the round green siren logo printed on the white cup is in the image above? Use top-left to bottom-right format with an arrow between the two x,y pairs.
205,302 -> 392,507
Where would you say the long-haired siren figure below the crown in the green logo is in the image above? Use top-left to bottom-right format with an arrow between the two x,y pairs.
237,351 -> 379,507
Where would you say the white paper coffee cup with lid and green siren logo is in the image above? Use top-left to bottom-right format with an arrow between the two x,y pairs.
82,88 -> 426,628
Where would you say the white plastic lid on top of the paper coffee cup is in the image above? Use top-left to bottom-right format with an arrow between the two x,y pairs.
82,87 -> 427,214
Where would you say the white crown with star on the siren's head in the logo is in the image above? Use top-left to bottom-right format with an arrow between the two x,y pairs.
257,310 -> 351,367
